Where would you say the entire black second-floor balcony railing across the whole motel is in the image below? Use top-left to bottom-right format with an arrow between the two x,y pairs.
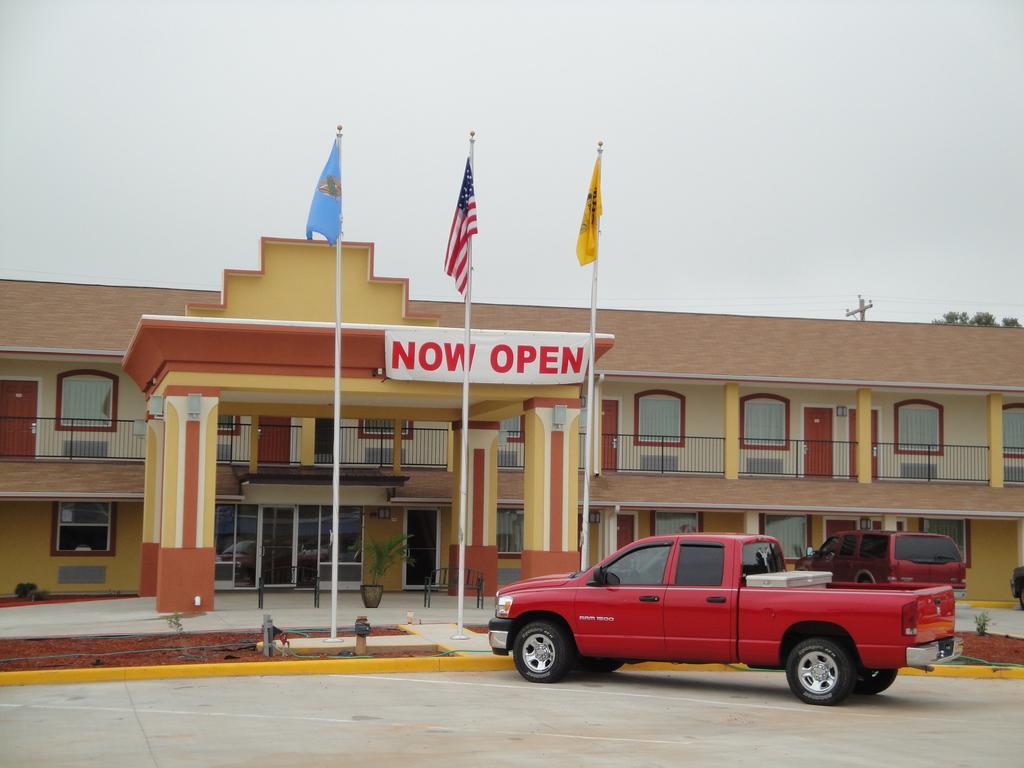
0,417 -> 1024,483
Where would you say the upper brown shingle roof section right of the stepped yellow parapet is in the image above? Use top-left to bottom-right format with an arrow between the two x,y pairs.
412,301 -> 1024,388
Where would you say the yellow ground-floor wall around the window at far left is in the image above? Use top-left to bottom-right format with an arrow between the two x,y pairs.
0,502 -> 142,594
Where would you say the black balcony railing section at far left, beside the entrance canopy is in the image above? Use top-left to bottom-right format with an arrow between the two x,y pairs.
0,416 -> 145,461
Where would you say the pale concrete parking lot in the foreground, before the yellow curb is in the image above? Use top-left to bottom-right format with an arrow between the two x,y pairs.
0,672 -> 1024,768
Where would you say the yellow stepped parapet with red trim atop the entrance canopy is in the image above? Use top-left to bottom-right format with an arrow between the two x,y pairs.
188,241 -> 437,326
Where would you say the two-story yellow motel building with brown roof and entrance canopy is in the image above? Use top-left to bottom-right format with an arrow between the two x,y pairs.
0,239 -> 1024,610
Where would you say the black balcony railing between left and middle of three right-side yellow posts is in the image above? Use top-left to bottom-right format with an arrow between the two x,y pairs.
739,438 -> 857,478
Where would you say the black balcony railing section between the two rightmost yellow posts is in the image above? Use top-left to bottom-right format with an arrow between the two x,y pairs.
871,442 -> 988,482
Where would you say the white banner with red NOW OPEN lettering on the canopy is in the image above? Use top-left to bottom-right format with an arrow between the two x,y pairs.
384,328 -> 590,384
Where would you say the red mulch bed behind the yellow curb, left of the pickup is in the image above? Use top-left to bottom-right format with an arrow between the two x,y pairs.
0,627 -> 415,673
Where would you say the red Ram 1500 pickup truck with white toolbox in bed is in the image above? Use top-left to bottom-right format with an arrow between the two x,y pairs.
488,534 -> 963,705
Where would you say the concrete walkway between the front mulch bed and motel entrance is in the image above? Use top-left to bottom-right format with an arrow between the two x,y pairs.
0,592 -> 494,642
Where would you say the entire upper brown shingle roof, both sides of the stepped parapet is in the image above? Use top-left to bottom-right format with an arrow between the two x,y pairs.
0,281 -> 1024,389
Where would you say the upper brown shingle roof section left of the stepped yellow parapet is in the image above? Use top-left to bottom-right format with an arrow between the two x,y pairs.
0,280 -> 220,352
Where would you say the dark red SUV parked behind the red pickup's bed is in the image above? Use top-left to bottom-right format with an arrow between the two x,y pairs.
797,530 -> 967,597
